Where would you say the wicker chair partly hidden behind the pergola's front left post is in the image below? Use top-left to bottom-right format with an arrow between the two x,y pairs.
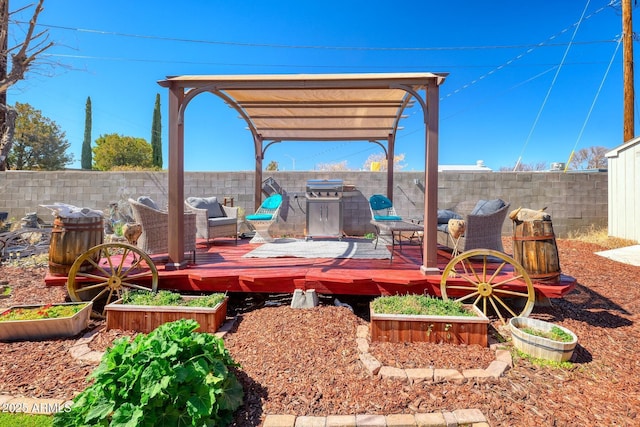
129,199 -> 196,262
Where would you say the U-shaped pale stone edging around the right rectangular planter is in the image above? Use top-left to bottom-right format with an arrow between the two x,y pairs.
356,325 -> 513,384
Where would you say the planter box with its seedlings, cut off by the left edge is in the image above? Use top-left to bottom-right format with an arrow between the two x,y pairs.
0,302 -> 93,341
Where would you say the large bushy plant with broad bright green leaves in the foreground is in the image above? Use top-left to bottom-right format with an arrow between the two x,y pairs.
53,319 -> 244,427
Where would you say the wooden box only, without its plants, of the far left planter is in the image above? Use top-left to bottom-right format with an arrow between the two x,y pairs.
0,302 -> 93,341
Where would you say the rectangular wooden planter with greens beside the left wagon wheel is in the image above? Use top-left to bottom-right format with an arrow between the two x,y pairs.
105,291 -> 229,333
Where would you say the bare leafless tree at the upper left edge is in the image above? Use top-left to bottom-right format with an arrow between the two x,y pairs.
0,0 -> 53,171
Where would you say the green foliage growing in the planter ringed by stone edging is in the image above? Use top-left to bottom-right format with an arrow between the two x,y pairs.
371,295 -> 476,317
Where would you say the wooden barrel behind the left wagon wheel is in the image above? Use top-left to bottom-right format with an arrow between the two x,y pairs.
49,217 -> 104,275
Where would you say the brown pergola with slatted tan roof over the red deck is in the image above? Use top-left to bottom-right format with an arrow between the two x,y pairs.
158,73 -> 447,273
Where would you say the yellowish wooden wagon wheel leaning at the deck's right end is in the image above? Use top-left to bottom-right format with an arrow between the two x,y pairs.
440,249 -> 536,324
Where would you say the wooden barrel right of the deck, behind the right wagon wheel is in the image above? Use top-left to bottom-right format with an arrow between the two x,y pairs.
513,221 -> 560,282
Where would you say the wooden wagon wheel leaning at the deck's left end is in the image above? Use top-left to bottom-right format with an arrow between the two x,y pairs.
67,243 -> 158,316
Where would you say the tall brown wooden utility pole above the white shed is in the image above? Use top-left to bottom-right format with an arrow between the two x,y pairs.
622,0 -> 635,143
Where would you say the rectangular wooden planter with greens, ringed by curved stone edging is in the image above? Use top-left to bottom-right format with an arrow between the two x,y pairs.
370,295 -> 489,347
